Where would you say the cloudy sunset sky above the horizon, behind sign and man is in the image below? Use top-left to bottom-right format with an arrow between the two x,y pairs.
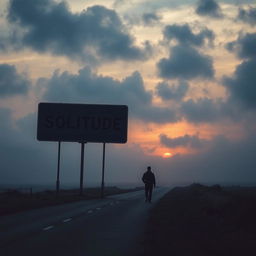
0,0 -> 256,186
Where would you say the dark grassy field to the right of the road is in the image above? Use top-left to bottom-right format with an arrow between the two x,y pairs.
144,184 -> 256,256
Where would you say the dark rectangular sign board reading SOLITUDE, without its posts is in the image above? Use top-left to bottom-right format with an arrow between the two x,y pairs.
37,103 -> 128,143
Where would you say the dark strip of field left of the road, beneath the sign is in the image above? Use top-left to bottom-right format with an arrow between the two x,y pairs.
0,186 -> 142,216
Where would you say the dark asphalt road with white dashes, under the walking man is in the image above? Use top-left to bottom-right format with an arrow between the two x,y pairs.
0,188 -> 169,256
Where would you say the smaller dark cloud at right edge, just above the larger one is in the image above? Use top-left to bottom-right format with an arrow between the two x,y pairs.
226,33 -> 256,59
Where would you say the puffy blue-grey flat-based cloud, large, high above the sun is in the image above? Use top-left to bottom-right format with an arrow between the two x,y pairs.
157,45 -> 214,79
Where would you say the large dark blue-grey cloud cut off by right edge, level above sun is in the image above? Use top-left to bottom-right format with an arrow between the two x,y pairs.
223,59 -> 256,109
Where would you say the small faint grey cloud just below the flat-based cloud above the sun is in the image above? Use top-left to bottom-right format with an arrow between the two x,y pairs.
156,81 -> 189,101
